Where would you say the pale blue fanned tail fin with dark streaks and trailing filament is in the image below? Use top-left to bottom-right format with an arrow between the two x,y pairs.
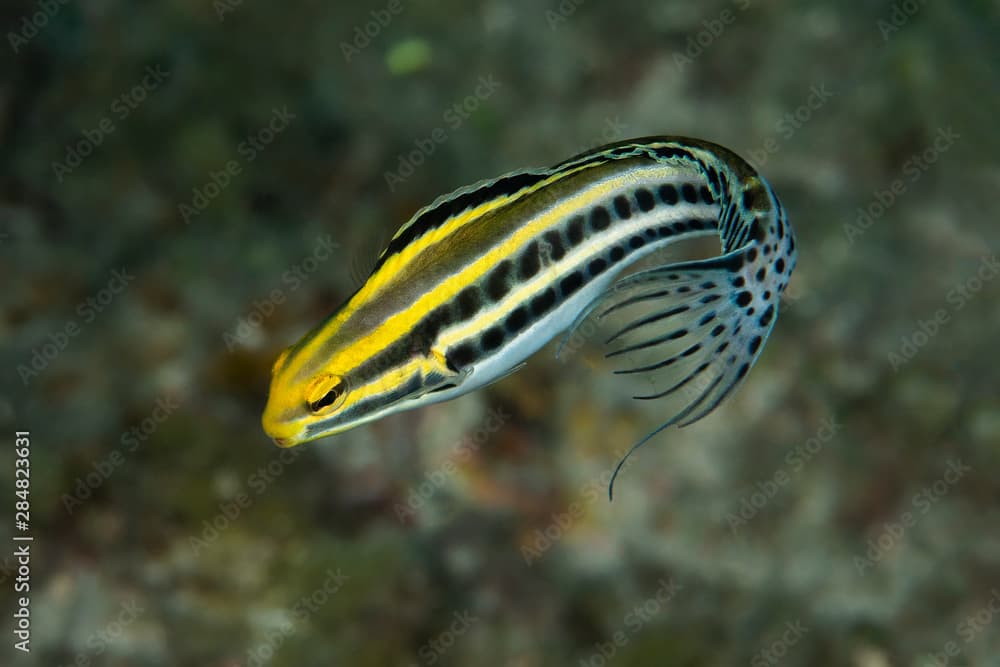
564,249 -> 777,498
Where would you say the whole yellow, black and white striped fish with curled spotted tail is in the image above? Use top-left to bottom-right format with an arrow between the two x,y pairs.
262,136 -> 797,497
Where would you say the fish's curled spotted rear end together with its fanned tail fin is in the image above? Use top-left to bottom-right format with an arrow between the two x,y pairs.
569,140 -> 796,497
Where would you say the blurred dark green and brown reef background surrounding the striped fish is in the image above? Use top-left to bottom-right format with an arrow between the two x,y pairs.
0,0 -> 1000,667
